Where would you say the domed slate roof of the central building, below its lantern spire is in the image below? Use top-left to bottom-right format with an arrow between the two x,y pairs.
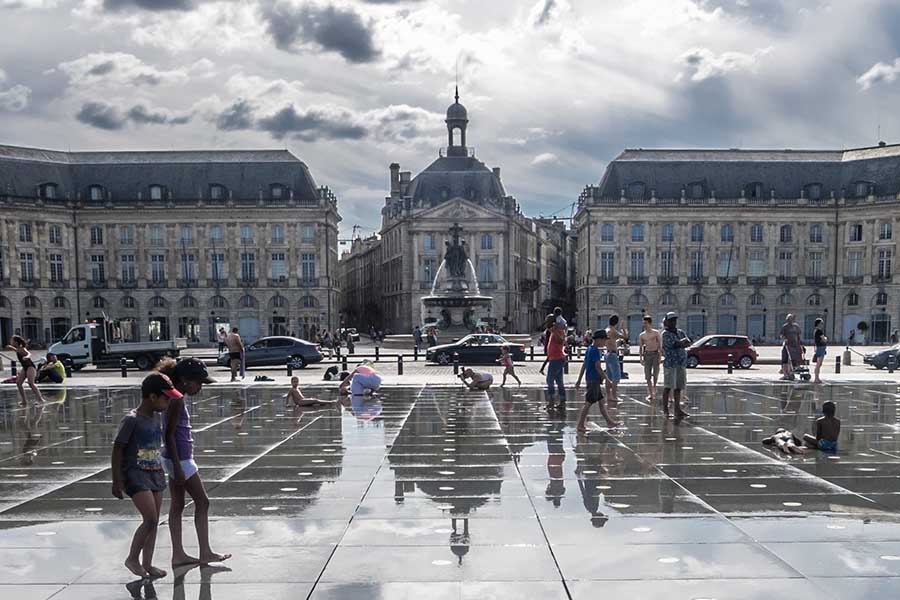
406,156 -> 506,202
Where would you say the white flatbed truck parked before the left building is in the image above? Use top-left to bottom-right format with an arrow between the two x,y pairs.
48,321 -> 187,371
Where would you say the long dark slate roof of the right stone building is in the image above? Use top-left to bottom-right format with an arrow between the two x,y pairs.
594,145 -> 900,198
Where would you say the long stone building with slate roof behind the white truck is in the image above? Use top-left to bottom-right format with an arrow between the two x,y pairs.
0,146 -> 340,344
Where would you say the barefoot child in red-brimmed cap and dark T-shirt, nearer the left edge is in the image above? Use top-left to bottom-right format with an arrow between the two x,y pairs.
112,373 -> 181,577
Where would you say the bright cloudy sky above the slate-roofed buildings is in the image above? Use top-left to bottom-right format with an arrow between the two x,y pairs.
0,0 -> 900,245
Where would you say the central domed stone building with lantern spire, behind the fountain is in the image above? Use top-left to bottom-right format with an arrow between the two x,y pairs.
342,93 -> 571,333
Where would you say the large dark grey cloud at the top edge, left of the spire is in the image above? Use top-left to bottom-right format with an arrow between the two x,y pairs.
260,1 -> 379,63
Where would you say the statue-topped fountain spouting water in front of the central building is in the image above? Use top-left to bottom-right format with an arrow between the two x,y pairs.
422,223 -> 494,335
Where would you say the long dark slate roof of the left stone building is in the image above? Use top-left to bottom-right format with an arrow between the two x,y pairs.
0,145 -> 318,203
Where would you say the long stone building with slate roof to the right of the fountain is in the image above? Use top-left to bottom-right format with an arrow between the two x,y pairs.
573,143 -> 900,342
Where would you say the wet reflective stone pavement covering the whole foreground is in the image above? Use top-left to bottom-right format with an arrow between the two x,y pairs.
0,384 -> 900,600
